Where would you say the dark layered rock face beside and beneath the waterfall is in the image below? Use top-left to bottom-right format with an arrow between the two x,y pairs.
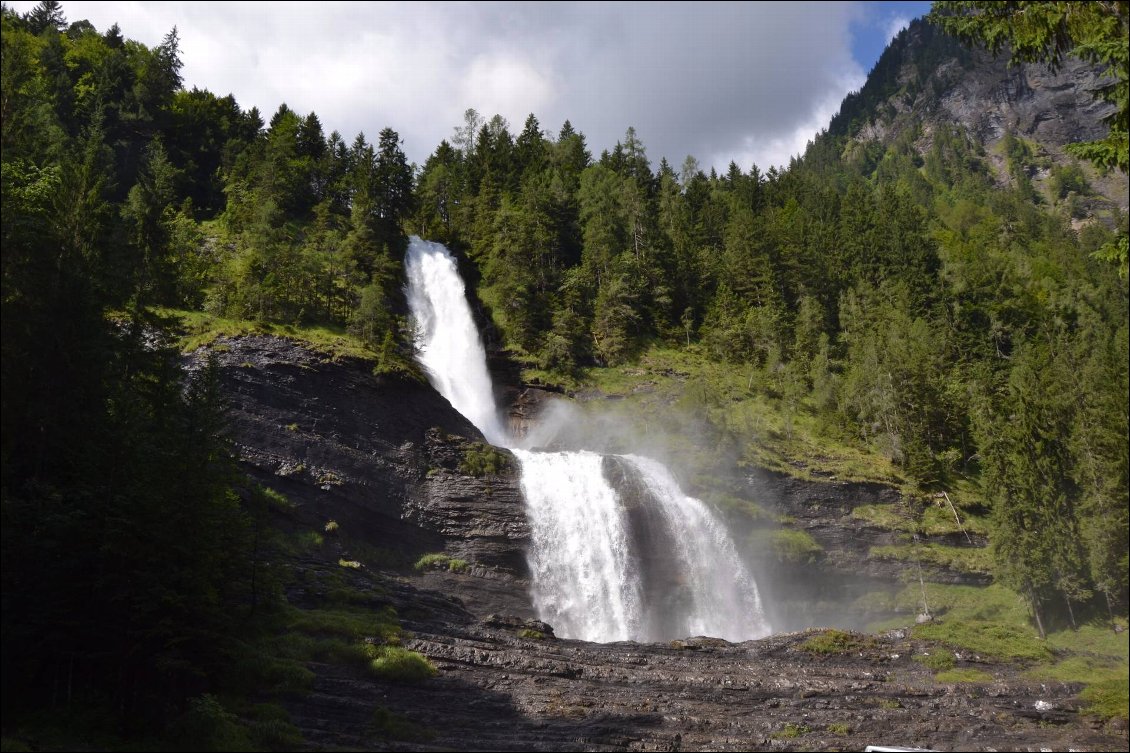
205,337 -> 1125,751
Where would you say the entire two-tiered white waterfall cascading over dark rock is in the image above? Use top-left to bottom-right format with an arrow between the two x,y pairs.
406,236 -> 770,642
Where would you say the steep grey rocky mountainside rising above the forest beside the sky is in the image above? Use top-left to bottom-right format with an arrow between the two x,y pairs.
820,20 -> 1130,213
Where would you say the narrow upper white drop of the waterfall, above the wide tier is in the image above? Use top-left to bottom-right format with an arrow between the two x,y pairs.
405,235 -> 510,447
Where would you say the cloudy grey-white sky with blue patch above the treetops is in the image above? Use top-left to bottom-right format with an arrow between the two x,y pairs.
9,0 -> 929,171
